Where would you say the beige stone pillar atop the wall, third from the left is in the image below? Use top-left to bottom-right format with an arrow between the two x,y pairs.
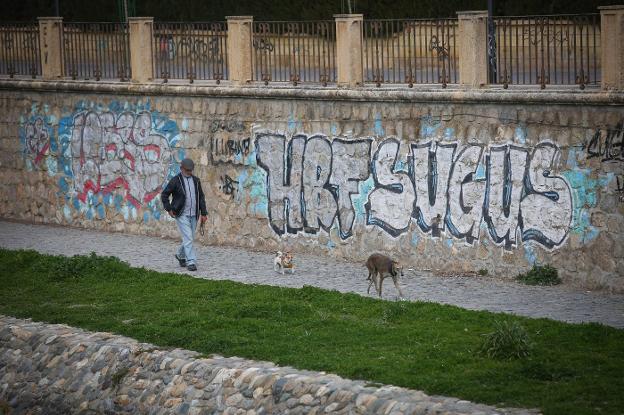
226,16 -> 253,85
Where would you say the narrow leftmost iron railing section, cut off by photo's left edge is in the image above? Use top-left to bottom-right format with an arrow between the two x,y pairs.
0,23 -> 41,78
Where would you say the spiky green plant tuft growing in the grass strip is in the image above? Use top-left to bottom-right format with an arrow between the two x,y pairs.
479,320 -> 532,359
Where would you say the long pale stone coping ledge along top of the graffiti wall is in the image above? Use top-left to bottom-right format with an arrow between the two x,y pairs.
0,79 -> 624,106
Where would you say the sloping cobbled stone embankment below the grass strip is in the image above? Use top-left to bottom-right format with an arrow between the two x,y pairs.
0,316 -> 536,415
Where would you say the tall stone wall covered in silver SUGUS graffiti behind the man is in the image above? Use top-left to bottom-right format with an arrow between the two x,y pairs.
0,81 -> 624,292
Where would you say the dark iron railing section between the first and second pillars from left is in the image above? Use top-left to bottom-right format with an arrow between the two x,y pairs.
63,22 -> 132,81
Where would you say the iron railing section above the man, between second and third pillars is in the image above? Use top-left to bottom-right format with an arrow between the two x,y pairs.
154,22 -> 228,83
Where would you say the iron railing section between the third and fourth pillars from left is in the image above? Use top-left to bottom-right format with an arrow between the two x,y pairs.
252,20 -> 337,85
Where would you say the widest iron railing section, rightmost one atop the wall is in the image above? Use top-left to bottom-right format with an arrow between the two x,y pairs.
490,14 -> 600,89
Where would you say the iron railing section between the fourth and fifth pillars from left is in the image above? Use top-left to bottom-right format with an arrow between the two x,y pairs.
362,19 -> 458,87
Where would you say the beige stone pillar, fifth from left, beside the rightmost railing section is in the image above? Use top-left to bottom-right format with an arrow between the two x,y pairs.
456,11 -> 488,88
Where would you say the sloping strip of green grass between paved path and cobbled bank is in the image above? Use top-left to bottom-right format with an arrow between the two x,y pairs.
0,250 -> 624,414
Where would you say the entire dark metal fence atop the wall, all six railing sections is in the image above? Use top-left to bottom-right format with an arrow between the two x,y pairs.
0,14 -> 602,89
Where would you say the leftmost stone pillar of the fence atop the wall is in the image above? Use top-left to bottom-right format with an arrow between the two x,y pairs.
38,17 -> 63,79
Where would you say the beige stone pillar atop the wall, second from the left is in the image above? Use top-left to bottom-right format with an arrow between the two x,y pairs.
128,17 -> 154,83
